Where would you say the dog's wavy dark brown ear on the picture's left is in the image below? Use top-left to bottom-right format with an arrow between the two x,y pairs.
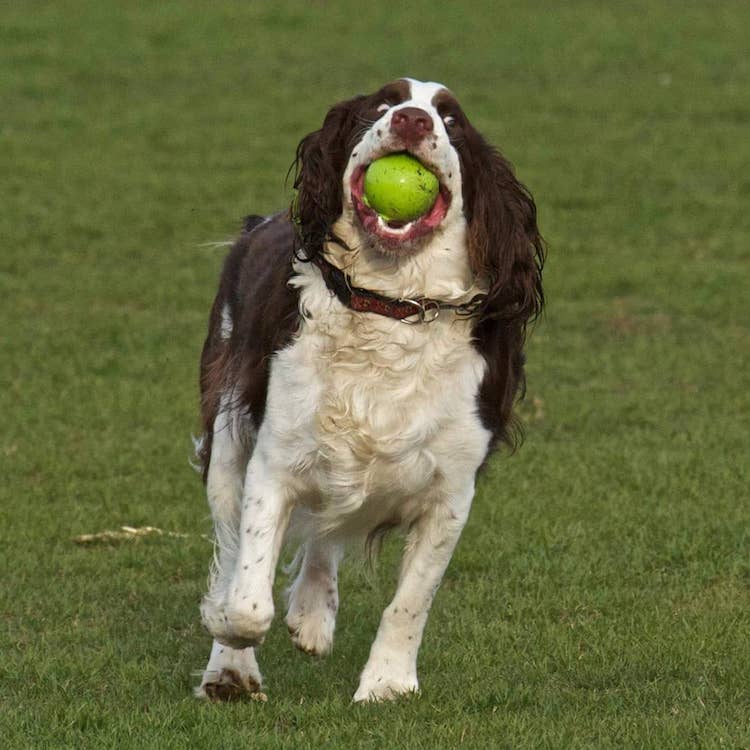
290,96 -> 366,259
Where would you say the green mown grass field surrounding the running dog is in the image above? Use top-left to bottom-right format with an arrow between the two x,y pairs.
0,0 -> 750,750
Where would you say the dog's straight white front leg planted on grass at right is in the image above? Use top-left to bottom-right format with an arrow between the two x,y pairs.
354,486 -> 474,701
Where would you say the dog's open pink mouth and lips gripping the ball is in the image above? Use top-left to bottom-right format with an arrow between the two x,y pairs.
350,154 -> 451,245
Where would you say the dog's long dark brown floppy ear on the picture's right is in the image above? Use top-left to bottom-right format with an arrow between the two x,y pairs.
461,131 -> 545,326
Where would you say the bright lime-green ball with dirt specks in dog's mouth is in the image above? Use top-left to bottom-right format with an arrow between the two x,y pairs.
364,154 -> 440,221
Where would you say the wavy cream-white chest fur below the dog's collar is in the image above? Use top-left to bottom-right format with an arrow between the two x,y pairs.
259,267 -> 489,532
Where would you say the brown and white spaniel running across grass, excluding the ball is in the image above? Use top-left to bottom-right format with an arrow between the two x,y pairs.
197,79 -> 544,701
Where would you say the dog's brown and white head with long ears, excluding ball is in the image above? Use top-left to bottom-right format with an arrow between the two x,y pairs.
292,78 -> 544,320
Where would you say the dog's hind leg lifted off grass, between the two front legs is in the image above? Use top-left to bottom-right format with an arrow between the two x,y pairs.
286,539 -> 343,656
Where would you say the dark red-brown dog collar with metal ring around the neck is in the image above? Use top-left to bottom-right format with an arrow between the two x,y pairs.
313,255 -> 487,323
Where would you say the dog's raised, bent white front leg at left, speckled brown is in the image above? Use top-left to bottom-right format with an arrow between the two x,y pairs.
214,452 -> 292,647
